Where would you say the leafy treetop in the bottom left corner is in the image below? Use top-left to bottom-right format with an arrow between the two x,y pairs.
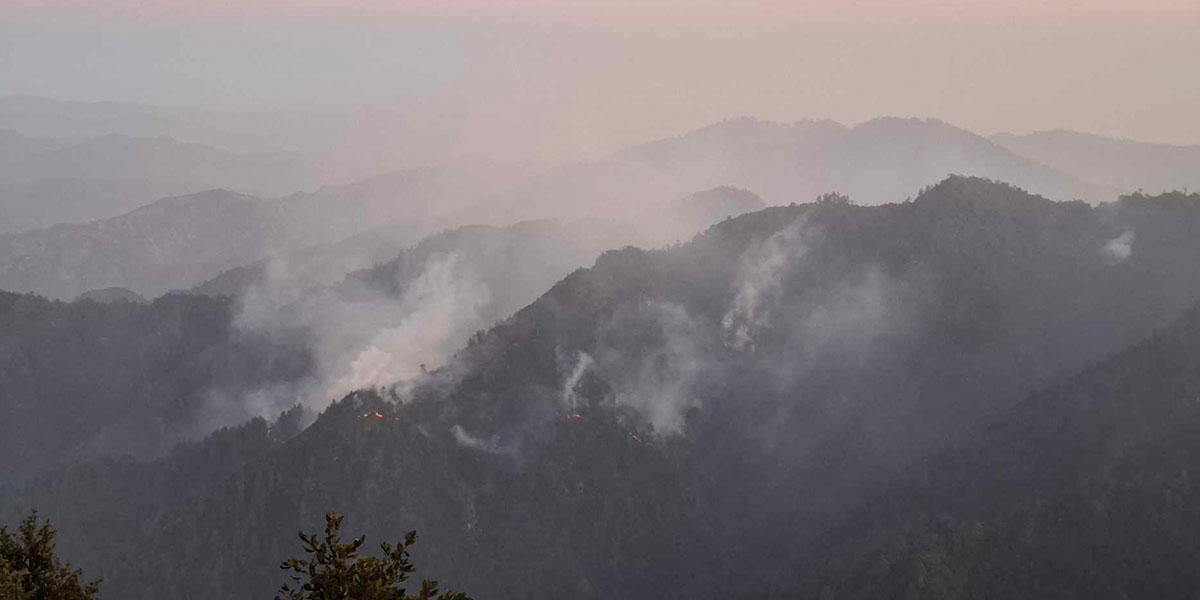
0,512 -> 100,600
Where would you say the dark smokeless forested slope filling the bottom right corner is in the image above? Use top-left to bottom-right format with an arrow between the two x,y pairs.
806,297 -> 1200,599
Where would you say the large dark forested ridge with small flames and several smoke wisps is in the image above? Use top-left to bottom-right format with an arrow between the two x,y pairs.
11,178 -> 1200,598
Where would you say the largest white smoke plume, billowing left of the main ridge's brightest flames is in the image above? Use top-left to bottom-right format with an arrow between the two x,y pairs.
217,253 -> 491,424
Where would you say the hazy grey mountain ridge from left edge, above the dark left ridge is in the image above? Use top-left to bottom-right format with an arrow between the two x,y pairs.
0,162 -> 525,299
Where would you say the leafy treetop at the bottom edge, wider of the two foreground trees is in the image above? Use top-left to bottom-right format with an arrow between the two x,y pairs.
276,512 -> 470,600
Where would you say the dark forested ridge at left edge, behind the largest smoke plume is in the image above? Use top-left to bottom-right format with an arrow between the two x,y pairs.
0,288 -> 312,479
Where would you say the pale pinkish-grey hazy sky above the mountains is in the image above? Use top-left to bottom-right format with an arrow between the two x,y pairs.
0,0 -> 1200,158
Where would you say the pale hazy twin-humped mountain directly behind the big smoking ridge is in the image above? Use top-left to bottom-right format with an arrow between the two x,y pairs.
463,118 -> 1122,226
